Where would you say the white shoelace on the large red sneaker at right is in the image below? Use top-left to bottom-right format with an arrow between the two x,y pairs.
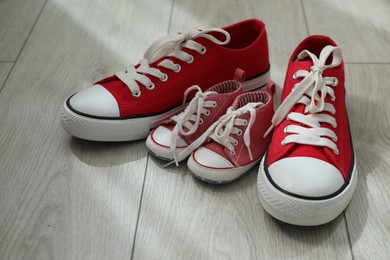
264,45 -> 342,154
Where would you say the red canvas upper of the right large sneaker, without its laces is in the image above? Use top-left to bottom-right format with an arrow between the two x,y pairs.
267,35 -> 353,180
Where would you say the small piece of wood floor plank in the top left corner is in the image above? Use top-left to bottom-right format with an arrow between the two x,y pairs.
0,0 -> 45,61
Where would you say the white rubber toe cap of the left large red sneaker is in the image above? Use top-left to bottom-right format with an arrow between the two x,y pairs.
69,85 -> 120,117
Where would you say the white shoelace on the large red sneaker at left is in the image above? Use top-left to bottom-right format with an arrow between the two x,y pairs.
115,28 -> 230,97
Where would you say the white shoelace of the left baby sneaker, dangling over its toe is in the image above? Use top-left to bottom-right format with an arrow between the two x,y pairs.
165,86 -> 217,166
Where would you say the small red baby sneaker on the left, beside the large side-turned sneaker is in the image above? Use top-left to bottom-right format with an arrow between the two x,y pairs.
146,69 -> 245,165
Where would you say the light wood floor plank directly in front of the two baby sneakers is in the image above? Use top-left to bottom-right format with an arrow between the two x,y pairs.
134,158 -> 351,259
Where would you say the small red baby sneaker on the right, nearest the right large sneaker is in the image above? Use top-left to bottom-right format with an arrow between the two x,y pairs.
188,81 -> 275,183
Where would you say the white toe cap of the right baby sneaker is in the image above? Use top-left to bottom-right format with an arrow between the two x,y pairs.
193,147 -> 234,168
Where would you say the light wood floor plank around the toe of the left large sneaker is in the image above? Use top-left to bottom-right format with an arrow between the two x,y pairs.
0,0 -> 171,259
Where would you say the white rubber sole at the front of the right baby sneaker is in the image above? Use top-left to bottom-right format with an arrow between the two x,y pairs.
187,156 -> 259,184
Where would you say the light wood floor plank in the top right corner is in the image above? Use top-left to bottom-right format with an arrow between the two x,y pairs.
303,0 -> 390,63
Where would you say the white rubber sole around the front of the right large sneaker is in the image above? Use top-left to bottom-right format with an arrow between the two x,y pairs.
257,156 -> 358,226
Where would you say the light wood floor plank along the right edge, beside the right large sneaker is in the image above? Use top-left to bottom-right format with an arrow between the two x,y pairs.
346,64 -> 390,259
